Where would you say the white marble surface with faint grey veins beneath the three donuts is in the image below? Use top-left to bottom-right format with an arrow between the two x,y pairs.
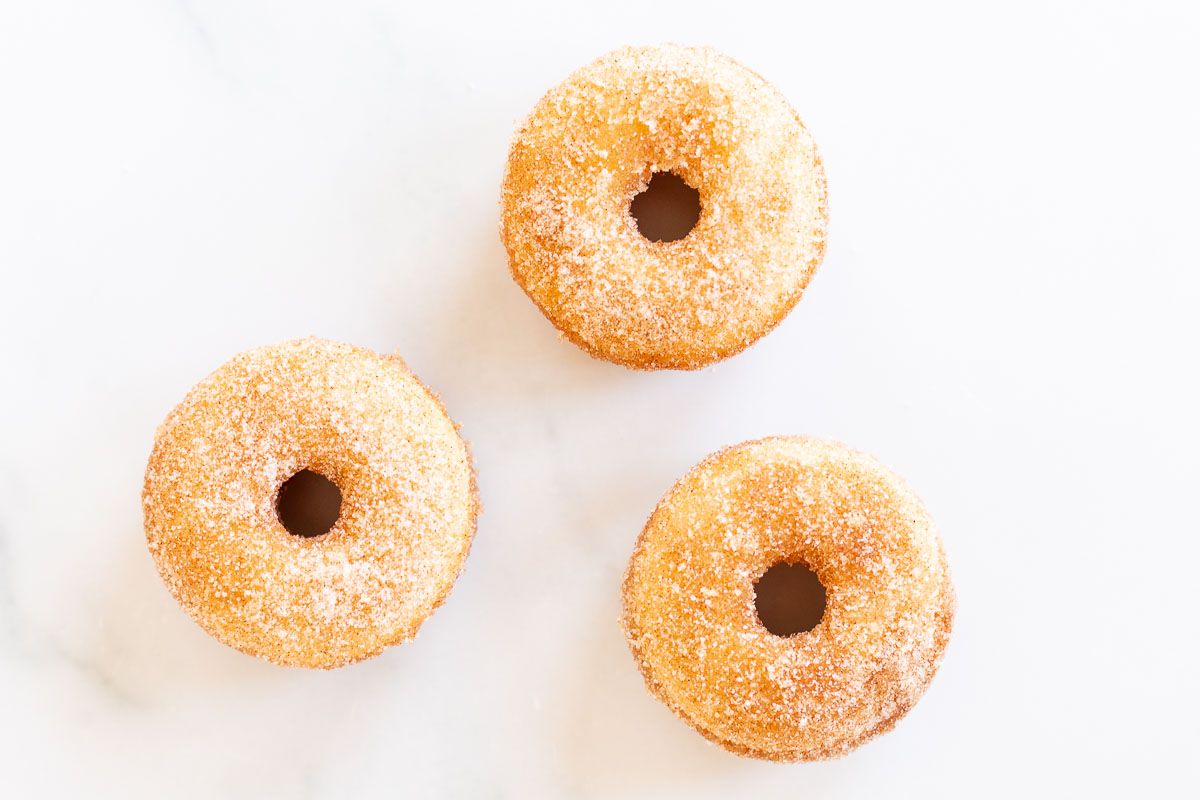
0,0 -> 1200,800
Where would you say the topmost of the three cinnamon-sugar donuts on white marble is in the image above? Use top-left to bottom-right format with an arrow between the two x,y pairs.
500,46 -> 828,369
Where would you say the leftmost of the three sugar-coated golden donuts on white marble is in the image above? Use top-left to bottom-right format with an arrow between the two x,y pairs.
142,338 -> 479,668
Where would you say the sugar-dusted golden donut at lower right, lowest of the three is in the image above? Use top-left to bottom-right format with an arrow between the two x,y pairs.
622,437 -> 954,762
